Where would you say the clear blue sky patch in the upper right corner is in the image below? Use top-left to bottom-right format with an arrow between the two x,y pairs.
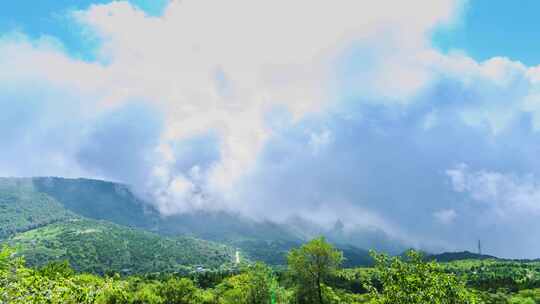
434,0 -> 540,65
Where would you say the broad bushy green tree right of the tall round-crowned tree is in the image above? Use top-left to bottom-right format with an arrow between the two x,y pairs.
370,250 -> 476,304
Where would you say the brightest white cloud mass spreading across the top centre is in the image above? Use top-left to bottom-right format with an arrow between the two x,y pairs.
0,0 -> 464,214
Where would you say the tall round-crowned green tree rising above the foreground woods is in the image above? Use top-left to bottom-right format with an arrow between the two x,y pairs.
287,237 -> 343,304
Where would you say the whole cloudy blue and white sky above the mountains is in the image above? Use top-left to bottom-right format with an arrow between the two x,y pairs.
0,0 -> 540,258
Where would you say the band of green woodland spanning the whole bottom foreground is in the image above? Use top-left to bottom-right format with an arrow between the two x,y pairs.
0,237 -> 540,304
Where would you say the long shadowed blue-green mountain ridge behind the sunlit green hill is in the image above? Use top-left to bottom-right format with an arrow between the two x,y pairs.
4,177 -> 390,266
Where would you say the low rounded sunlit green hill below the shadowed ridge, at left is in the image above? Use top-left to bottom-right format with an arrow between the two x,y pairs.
7,219 -> 234,273
